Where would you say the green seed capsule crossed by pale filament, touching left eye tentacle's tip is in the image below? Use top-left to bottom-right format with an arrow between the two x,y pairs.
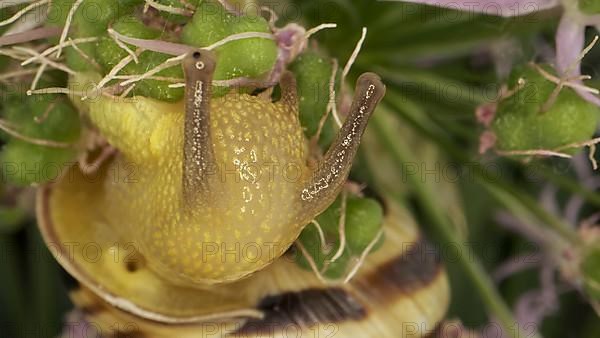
181,2 -> 277,87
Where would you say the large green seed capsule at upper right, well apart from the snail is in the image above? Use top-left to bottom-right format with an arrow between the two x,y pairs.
492,63 -> 599,153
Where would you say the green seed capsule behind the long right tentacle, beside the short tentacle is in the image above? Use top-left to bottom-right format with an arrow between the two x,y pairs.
290,51 -> 335,148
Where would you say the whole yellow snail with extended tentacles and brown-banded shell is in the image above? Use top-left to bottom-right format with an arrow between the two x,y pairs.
37,50 -> 449,337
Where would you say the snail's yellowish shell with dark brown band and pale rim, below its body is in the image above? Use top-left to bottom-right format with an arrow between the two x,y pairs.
37,160 -> 449,336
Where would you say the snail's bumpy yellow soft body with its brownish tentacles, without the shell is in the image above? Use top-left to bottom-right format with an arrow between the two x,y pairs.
83,50 -> 384,287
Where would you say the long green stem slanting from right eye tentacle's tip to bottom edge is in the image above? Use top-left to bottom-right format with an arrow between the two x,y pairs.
372,116 -> 538,338
